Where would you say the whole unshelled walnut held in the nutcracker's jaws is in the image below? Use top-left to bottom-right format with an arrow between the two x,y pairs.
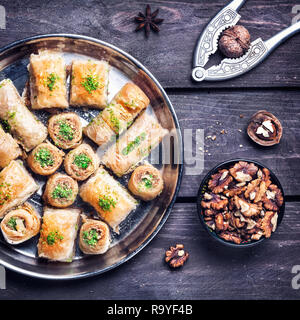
219,25 -> 250,58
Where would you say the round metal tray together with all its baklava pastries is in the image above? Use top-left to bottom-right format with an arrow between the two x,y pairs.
0,35 -> 182,279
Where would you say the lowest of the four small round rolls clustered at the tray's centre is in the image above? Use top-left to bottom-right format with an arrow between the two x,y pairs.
43,173 -> 78,208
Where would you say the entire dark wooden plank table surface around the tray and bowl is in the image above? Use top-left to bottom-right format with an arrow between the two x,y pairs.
0,0 -> 300,299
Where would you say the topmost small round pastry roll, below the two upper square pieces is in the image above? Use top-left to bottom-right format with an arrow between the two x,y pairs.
48,112 -> 82,149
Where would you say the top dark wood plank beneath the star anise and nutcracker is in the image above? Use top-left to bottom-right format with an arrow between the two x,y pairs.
0,0 -> 300,88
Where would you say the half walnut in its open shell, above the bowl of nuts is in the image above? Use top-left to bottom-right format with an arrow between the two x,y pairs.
247,110 -> 282,146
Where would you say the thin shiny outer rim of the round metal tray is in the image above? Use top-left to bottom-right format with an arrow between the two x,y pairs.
0,33 -> 184,280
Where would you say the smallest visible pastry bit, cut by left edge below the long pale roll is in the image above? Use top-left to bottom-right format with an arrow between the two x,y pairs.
0,125 -> 22,168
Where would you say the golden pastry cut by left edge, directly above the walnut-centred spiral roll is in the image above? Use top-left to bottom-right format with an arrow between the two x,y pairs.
0,160 -> 39,218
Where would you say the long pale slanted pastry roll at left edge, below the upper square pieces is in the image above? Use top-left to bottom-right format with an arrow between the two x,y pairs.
0,79 -> 47,151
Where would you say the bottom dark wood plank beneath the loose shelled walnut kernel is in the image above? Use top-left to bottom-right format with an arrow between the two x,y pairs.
0,203 -> 300,300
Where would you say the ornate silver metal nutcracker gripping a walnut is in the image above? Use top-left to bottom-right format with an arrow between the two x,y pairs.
192,0 -> 300,82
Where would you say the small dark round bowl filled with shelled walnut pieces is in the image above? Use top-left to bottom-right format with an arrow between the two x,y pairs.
197,159 -> 285,248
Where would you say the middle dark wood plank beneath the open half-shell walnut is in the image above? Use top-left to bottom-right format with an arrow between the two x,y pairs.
170,90 -> 300,196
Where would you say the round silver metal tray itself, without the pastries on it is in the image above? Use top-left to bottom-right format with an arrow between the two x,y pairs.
0,34 -> 183,280
